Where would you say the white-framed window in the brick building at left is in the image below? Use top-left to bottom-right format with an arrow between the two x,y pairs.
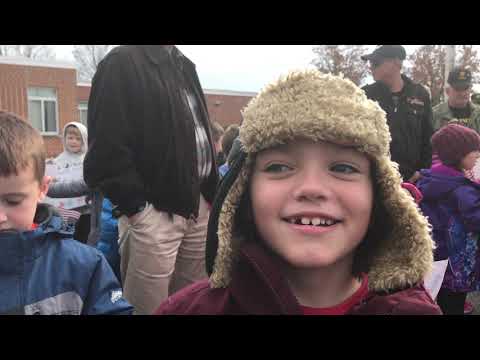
27,87 -> 58,135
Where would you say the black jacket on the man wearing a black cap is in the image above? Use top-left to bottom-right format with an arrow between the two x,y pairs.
363,75 -> 433,181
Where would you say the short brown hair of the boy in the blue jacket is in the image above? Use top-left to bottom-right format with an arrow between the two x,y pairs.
0,110 -> 46,182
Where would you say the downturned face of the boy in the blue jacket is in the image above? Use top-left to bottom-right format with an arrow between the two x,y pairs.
0,165 -> 49,231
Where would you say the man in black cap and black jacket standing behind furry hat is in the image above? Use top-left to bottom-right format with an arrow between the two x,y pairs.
362,45 -> 433,182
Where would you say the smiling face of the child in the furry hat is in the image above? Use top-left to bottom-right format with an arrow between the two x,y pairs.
250,140 -> 373,268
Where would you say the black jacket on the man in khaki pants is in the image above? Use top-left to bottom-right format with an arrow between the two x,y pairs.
84,45 -> 218,218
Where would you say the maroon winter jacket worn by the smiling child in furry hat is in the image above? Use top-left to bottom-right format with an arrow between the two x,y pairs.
155,243 -> 442,315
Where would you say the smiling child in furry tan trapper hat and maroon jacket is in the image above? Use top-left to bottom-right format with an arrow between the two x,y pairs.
156,70 -> 441,315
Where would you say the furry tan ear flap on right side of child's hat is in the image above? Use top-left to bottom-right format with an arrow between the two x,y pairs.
368,156 -> 435,291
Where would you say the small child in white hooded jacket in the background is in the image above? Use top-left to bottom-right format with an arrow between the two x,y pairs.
47,121 -> 90,243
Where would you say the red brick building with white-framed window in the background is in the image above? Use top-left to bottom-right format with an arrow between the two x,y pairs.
0,57 -> 256,157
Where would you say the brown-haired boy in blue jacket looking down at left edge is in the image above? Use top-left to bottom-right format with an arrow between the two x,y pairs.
0,111 -> 133,315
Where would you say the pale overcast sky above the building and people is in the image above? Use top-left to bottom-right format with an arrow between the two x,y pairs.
52,45 -> 424,92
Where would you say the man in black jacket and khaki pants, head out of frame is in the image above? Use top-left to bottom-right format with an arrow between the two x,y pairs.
84,45 -> 218,314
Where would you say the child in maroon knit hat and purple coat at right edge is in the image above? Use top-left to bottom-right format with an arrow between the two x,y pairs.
417,123 -> 480,315
